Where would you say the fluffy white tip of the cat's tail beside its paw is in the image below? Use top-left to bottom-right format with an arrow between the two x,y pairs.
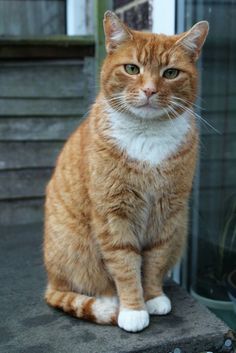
92,297 -> 118,323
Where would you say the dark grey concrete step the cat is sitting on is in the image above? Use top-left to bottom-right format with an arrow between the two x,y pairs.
0,224 -> 232,353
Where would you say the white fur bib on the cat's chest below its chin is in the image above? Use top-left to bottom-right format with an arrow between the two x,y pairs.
110,111 -> 190,166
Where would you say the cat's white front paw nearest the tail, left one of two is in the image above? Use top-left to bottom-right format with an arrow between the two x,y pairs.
118,309 -> 149,332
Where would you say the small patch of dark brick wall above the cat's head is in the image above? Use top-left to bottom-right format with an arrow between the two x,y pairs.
113,0 -> 152,30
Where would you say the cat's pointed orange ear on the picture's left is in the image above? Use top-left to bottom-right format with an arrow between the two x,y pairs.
103,11 -> 133,53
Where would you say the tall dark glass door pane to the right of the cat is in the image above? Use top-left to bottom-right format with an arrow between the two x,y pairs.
180,0 -> 236,328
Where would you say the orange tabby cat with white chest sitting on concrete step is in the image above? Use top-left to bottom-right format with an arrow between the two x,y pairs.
44,11 -> 208,332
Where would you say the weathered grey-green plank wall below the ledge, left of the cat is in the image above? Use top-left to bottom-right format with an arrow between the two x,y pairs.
0,57 -> 95,225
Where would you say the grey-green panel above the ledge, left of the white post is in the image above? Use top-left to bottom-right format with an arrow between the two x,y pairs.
0,0 -> 65,36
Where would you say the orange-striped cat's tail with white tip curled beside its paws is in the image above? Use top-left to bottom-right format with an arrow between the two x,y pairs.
45,285 -> 119,325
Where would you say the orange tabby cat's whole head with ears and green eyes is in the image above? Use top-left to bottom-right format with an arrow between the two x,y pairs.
101,11 -> 209,119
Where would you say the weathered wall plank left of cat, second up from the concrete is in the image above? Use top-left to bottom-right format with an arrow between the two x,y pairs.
0,168 -> 52,200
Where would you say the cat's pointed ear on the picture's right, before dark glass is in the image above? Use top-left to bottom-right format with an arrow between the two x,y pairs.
176,21 -> 209,60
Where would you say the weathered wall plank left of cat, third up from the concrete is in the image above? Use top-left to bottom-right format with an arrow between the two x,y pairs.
0,141 -> 64,170
